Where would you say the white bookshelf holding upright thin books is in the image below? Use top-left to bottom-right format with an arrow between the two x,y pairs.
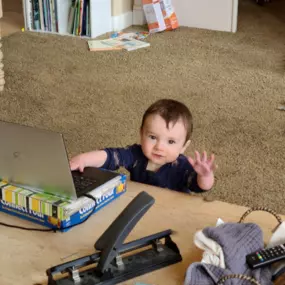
22,0 -> 112,38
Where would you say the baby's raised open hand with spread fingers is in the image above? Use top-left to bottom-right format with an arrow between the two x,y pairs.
188,151 -> 217,177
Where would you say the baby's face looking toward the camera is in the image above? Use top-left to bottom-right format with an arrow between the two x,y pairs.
141,115 -> 189,166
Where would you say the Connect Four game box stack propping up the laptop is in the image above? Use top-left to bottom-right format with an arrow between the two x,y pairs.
0,170 -> 126,231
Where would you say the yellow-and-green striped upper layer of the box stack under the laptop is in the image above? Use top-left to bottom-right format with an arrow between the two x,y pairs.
0,170 -> 126,220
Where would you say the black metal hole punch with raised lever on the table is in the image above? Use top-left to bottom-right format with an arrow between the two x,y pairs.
46,192 -> 182,285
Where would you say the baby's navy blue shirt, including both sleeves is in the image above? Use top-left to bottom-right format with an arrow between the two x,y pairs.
102,144 -> 204,193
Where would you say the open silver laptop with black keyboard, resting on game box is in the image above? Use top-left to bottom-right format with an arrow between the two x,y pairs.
0,121 -> 119,200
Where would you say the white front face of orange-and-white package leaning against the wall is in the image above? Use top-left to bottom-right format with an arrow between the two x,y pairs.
142,0 -> 166,33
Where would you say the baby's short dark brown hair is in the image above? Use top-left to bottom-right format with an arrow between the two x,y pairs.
141,99 -> 193,143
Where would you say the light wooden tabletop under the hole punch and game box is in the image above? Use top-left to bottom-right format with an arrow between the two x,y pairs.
0,182 -> 284,285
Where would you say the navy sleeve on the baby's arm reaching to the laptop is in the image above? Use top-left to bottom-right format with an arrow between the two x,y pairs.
102,146 -> 134,170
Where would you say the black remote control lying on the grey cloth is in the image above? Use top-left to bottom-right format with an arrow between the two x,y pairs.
246,244 -> 285,269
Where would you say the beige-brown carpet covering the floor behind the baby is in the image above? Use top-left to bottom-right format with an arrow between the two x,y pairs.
0,0 -> 285,213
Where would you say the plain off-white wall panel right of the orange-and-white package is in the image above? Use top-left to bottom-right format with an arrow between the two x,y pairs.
172,0 -> 238,32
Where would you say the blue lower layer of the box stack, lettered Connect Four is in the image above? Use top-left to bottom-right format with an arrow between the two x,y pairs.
0,175 -> 126,232
